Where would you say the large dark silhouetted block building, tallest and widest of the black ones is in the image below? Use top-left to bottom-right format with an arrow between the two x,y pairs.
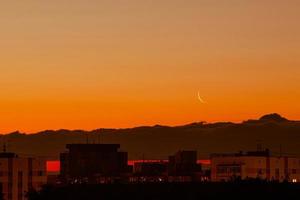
60,144 -> 130,183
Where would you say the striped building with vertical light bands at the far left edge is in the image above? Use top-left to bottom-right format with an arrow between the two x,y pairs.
0,152 -> 47,200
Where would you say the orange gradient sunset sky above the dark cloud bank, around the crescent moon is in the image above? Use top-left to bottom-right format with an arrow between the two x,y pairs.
0,0 -> 300,133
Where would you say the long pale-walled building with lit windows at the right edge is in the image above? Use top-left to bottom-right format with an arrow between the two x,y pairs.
211,149 -> 300,182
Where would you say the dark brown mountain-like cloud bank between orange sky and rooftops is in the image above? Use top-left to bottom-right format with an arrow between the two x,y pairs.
1,114 -> 300,159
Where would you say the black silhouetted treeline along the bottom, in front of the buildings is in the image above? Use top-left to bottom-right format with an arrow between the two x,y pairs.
28,181 -> 300,200
